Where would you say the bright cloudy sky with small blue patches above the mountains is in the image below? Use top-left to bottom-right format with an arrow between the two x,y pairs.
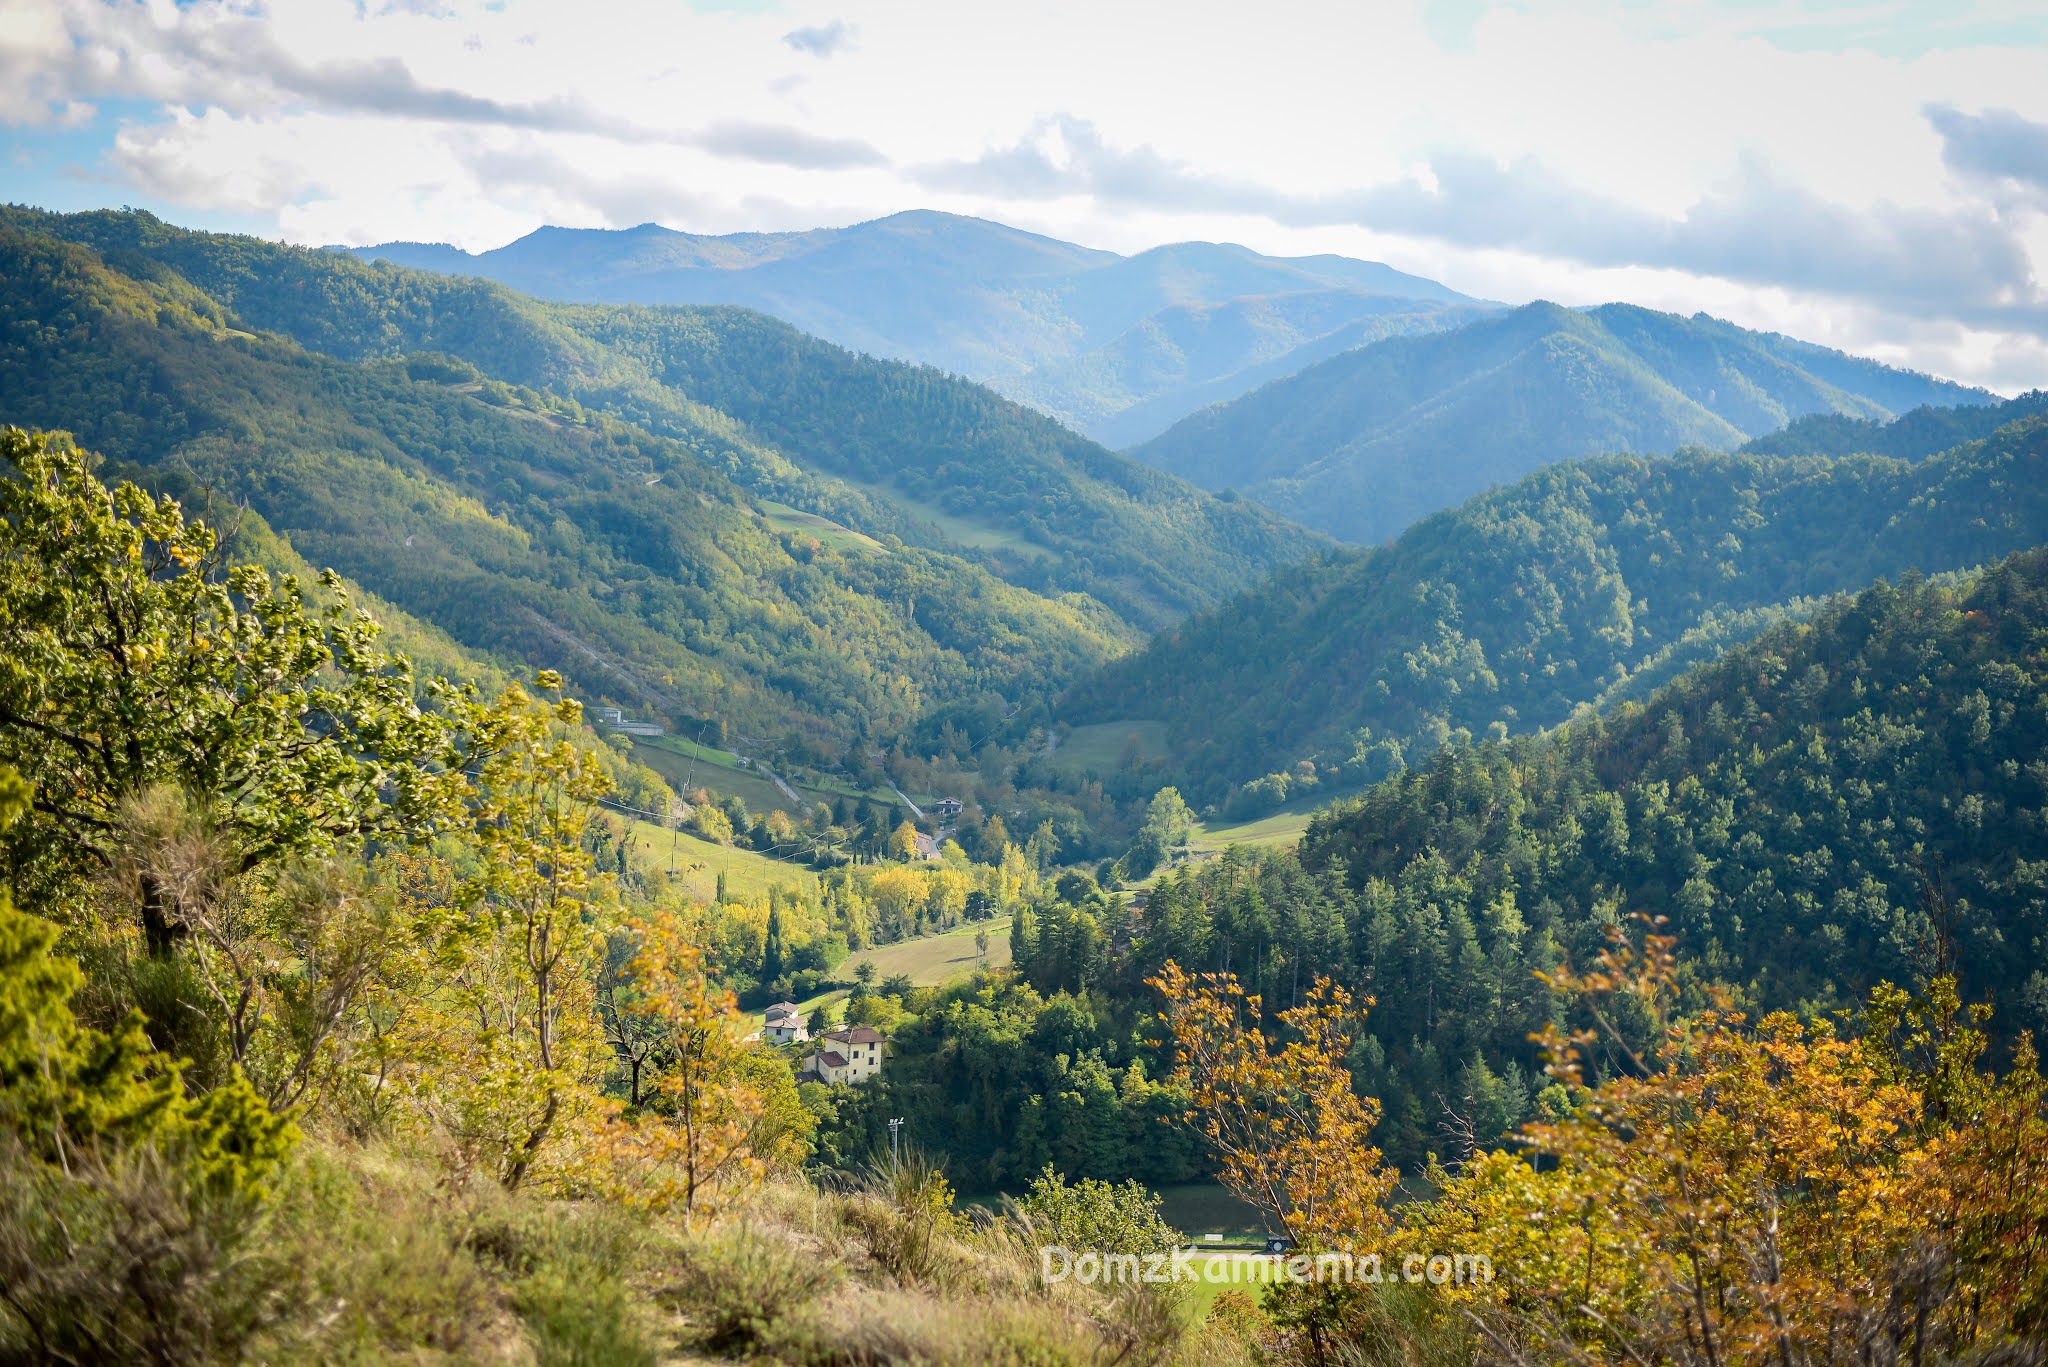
0,0 -> 2048,393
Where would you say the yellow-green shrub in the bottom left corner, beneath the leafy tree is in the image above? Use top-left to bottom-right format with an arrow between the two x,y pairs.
0,898 -> 297,1363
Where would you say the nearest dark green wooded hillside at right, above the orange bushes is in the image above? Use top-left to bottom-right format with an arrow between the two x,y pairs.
1003,549 -> 2048,1166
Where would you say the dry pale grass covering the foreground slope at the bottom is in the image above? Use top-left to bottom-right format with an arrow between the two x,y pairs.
4,1137 -> 1243,1367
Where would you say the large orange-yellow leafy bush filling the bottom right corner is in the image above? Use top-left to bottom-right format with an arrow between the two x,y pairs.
1407,922 -> 2048,1367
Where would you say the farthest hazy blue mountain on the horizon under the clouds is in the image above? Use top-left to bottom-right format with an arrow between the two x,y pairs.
354,211 -> 1493,445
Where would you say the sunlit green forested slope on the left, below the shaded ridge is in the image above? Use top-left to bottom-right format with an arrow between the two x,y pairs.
0,232 -> 1128,754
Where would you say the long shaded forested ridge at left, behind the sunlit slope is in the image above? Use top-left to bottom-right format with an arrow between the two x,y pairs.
4,209 -> 1315,631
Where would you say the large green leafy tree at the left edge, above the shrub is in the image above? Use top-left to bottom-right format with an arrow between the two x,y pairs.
0,428 -> 461,955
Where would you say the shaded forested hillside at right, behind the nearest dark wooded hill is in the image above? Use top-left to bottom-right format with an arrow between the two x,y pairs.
1063,416 -> 2048,812
